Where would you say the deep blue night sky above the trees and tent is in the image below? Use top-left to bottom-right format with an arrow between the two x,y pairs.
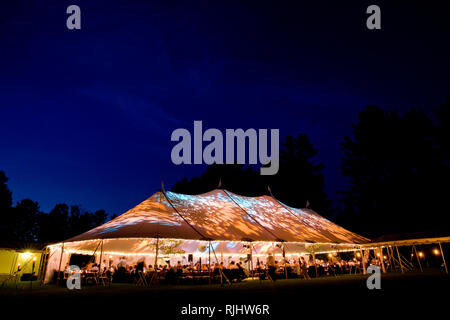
0,0 -> 450,214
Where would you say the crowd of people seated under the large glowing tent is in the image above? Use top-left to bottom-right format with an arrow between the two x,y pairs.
57,254 -> 389,284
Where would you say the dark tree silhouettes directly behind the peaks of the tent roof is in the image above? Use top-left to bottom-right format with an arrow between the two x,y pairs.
172,134 -> 331,215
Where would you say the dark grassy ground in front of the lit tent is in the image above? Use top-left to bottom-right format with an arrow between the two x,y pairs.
0,270 -> 450,319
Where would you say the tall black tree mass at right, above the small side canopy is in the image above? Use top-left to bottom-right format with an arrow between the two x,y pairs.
339,105 -> 449,237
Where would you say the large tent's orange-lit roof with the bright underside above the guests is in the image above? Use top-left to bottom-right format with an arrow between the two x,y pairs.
46,189 -> 369,280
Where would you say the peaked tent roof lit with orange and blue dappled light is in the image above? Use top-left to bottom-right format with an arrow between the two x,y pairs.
66,189 -> 369,244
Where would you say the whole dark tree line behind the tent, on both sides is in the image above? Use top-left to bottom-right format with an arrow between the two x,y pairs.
0,100 -> 450,242
